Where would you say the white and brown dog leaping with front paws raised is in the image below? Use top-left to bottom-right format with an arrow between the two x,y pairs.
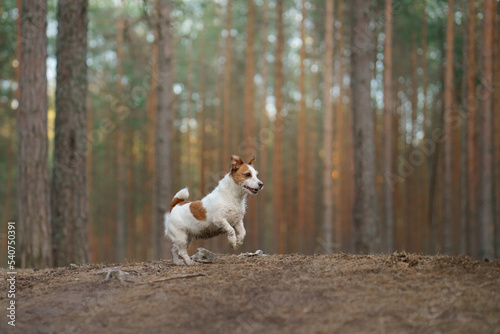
165,155 -> 264,265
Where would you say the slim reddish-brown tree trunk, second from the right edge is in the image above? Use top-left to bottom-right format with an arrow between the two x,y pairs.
467,0 -> 479,257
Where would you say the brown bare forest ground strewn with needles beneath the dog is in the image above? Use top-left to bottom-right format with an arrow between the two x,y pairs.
0,253 -> 500,334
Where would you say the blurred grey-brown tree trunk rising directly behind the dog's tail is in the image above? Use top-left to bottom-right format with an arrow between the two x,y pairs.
151,0 -> 173,259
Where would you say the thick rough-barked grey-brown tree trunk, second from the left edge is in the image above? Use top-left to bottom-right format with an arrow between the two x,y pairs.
51,0 -> 89,266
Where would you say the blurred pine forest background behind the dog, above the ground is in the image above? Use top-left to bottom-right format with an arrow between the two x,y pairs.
0,0 -> 500,266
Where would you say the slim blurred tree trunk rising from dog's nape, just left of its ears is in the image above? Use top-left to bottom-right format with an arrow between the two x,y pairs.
221,0 -> 233,170
